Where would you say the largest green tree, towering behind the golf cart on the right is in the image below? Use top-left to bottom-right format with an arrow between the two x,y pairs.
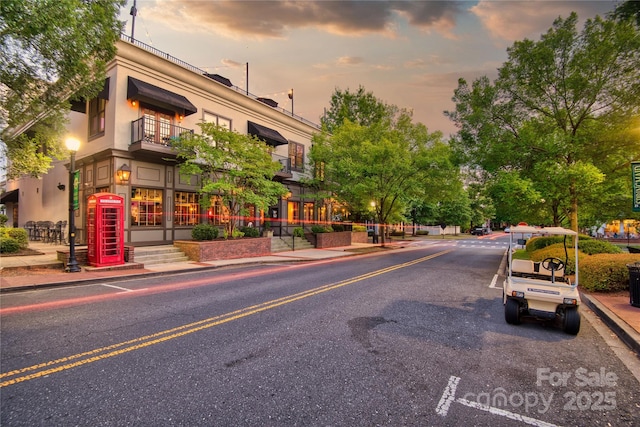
446,13 -> 640,230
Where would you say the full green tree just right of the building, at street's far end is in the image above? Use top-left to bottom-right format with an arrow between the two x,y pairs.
310,111 -> 459,244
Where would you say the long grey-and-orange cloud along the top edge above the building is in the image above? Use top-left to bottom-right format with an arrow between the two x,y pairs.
145,0 -> 460,39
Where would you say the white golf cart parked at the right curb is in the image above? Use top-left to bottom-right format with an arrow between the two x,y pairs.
503,225 -> 580,335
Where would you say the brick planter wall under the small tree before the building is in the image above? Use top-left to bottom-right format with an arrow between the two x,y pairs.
173,237 -> 271,262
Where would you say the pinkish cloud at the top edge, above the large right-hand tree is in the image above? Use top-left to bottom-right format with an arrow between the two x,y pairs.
469,0 -> 612,42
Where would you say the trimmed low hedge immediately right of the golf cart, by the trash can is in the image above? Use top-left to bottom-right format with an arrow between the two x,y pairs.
579,254 -> 640,292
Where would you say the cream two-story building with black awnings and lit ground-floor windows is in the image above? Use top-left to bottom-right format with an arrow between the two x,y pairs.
3,36 -> 330,245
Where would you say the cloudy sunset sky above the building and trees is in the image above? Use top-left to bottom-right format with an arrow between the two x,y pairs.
120,0 -> 617,138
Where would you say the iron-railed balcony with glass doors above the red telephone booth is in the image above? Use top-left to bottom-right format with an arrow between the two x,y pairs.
129,117 -> 193,157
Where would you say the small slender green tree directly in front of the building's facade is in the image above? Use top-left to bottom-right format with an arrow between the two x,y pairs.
172,123 -> 287,236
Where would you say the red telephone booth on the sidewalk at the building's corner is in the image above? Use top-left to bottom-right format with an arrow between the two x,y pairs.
87,193 -> 124,267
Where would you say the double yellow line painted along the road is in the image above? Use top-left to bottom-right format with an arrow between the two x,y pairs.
0,250 -> 451,388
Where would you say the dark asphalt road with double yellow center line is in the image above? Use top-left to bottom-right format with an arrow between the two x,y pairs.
0,240 -> 640,427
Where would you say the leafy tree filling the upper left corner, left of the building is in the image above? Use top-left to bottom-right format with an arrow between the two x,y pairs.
0,0 -> 125,178
